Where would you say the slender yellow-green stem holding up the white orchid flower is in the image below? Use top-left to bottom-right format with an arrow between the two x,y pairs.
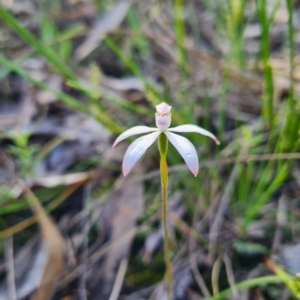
158,133 -> 172,300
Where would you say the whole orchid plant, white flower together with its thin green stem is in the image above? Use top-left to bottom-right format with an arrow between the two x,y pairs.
113,102 -> 220,300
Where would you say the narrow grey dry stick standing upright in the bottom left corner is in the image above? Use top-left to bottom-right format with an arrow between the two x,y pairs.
5,236 -> 17,300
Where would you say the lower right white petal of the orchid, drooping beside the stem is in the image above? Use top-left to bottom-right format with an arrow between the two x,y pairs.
164,131 -> 199,176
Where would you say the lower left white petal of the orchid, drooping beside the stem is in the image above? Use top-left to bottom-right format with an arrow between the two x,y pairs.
122,131 -> 161,176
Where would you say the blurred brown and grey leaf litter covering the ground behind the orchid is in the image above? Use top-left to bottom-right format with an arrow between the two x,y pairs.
0,0 -> 300,300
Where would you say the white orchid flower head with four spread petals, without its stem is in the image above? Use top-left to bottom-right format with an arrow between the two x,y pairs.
113,102 -> 220,176
